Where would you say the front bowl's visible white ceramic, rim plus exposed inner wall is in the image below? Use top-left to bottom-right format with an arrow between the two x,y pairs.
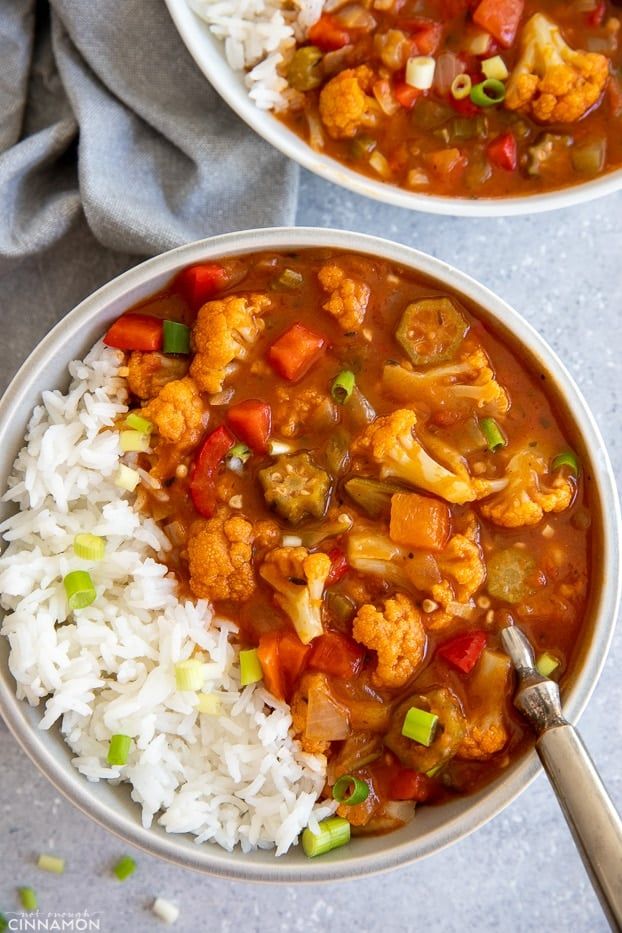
0,228 -> 620,882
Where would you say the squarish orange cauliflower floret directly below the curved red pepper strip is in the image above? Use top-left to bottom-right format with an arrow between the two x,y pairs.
188,509 -> 256,602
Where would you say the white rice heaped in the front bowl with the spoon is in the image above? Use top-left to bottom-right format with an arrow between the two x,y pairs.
0,343 -> 333,855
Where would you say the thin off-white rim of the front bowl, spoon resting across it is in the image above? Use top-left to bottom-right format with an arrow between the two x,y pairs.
0,227 -> 622,883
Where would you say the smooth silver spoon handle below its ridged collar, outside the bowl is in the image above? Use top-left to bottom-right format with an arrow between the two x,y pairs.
536,724 -> 622,930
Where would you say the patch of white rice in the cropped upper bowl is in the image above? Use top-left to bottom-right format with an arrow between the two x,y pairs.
188,0 -> 324,110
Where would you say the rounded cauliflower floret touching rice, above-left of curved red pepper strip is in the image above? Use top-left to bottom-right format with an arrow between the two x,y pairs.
141,376 -> 204,448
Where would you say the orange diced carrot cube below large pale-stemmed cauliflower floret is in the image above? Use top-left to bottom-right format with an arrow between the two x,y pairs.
389,492 -> 451,551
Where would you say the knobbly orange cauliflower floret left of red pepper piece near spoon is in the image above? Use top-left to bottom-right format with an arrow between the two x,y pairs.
352,593 -> 426,687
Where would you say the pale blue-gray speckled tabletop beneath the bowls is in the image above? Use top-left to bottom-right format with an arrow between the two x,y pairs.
0,175 -> 622,933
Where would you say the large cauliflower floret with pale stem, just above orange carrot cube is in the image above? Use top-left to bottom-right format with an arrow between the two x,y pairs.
353,408 -> 505,503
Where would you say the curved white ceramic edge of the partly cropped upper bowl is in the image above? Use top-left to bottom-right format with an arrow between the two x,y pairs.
166,0 -> 622,217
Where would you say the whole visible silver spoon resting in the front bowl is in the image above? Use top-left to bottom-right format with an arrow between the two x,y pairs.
501,625 -> 622,930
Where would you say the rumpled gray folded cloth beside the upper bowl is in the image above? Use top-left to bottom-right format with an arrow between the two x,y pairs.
0,0 -> 298,271
